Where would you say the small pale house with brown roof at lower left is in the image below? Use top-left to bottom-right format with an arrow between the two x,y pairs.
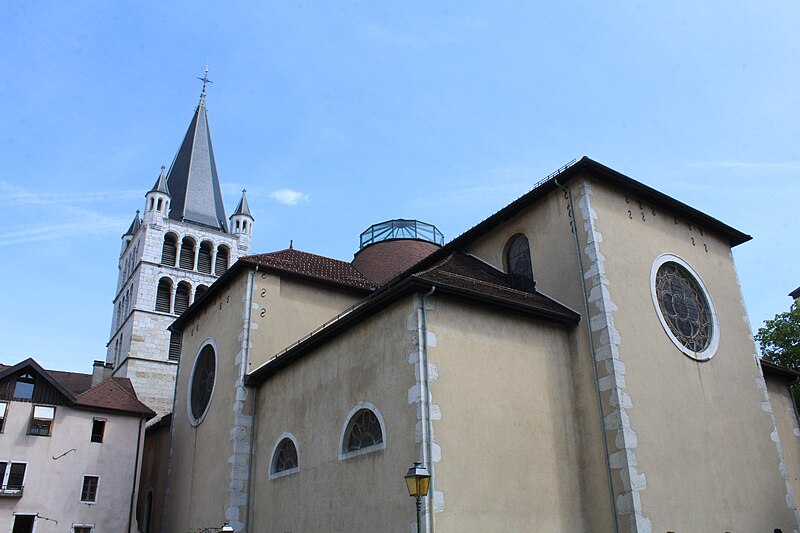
0,359 -> 155,533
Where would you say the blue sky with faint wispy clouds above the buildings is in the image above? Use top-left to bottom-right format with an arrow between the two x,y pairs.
0,1 -> 800,372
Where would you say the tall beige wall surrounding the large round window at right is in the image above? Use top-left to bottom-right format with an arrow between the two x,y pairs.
574,177 -> 796,531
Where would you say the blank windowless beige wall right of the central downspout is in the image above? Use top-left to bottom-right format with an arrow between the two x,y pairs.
428,298 -> 592,533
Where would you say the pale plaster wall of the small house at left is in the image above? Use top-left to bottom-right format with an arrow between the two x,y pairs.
0,401 -> 144,533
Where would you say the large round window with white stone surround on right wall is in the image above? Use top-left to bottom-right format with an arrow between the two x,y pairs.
653,255 -> 717,361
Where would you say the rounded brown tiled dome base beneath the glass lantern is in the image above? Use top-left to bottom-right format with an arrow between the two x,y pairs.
353,239 -> 440,284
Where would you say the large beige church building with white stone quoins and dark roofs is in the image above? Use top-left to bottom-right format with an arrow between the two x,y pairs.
161,158 -> 800,533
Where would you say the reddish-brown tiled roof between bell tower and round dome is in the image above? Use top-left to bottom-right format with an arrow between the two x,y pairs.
241,248 -> 376,289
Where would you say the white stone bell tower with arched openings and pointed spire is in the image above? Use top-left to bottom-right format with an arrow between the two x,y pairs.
106,88 -> 253,415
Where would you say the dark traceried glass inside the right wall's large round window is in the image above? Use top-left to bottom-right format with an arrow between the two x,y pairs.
656,262 -> 713,352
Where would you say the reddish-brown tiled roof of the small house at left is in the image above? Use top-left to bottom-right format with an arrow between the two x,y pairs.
0,358 -> 155,418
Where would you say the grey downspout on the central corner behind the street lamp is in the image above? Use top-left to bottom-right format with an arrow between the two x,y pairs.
417,285 -> 436,533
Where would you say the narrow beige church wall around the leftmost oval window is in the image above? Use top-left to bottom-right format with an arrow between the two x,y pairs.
166,272 -> 247,532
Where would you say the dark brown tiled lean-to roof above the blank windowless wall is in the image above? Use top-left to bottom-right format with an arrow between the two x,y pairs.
413,252 -> 580,323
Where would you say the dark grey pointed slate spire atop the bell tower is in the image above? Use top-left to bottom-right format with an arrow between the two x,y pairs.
167,97 -> 227,232
